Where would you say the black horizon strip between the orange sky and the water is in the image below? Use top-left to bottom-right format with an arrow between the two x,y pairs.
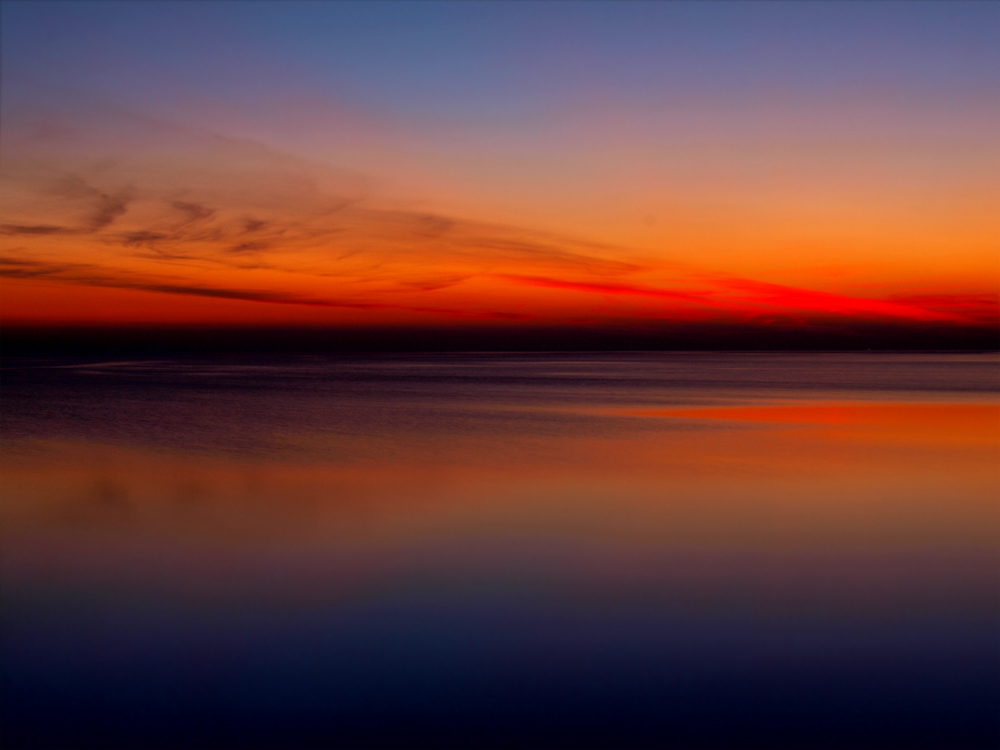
0,322 -> 1000,357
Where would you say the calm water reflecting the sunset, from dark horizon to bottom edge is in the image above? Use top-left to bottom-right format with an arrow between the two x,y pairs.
0,353 -> 1000,748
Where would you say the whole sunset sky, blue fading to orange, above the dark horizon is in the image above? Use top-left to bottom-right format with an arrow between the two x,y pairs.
0,0 -> 1000,329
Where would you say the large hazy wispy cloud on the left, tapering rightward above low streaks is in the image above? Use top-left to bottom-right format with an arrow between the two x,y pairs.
0,94 -> 644,294
